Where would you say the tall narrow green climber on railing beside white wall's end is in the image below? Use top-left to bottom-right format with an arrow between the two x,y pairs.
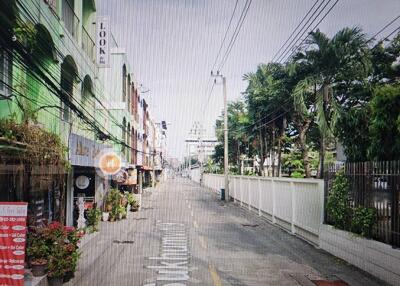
326,170 -> 351,229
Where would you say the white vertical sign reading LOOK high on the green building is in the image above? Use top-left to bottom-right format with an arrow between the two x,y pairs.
96,17 -> 110,67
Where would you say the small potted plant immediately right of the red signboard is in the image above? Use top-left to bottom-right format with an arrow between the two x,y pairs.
26,229 -> 49,277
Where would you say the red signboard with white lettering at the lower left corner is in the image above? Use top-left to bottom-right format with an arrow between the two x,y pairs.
0,202 -> 28,286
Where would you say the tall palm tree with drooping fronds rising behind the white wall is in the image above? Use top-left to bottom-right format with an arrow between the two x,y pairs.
294,28 -> 371,177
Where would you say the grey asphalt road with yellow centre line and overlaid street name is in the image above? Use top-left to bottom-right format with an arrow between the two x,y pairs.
67,178 -> 385,286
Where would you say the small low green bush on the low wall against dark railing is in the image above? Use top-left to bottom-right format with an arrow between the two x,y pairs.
350,207 -> 378,237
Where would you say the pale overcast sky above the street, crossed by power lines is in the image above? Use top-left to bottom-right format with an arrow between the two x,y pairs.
97,0 -> 400,158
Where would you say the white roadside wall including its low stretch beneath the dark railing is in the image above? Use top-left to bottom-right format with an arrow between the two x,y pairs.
203,174 -> 400,285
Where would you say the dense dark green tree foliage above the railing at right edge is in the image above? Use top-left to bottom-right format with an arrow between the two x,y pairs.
369,85 -> 400,161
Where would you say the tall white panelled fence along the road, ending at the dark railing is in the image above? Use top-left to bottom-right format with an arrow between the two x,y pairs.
203,174 -> 324,245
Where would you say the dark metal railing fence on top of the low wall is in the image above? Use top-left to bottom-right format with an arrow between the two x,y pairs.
325,161 -> 400,247
